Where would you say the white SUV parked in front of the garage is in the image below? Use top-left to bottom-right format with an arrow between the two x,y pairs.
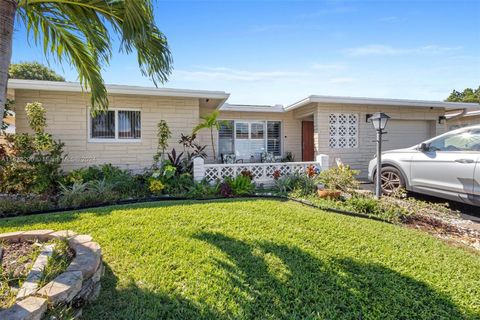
368,125 -> 480,206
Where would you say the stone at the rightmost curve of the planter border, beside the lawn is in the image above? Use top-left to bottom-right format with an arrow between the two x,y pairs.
67,242 -> 102,279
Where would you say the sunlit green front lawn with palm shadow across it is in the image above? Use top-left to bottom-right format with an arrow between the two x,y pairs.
0,199 -> 480,319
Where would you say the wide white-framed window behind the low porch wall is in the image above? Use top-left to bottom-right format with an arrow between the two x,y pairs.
218,120 -> 282,161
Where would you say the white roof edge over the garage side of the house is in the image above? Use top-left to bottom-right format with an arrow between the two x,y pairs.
285,95 -> 480,111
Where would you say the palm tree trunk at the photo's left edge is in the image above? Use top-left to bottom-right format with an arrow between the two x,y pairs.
0,0 -> 17,121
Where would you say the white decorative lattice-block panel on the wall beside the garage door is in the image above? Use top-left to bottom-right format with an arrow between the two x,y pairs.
328,113 -> 358,149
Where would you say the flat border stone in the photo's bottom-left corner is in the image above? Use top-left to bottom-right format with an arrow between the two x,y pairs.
0,297 -> 47,320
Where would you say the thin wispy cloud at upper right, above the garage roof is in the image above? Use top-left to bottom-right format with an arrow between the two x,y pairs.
345,44 -> 462,57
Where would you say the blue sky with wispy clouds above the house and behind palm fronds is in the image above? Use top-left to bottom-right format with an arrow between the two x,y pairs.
12,0 -> 480,105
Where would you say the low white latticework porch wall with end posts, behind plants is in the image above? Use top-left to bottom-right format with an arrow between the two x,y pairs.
193,154 -> 328,185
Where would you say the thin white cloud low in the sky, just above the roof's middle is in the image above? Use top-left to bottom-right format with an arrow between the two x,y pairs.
174,67 -> 308,82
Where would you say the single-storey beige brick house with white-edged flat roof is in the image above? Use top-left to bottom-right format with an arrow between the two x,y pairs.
9,80 -> 478,177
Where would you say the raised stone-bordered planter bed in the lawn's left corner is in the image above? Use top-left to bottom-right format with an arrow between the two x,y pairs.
0,230 -> 103,320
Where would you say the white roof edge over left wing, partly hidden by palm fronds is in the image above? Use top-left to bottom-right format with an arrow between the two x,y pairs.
8,79 -> 230,102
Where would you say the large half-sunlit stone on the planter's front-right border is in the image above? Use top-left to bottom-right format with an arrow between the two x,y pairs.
37,271 -> 83,305
